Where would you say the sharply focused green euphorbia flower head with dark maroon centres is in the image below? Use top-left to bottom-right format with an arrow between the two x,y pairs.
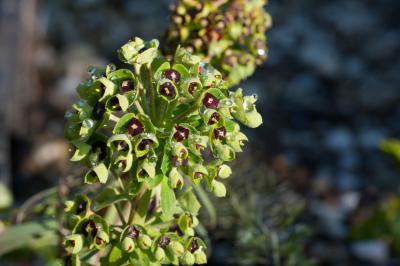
64,38 -> 262,265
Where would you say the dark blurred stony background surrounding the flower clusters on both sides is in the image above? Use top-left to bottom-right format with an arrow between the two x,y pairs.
0,0 -> 400,265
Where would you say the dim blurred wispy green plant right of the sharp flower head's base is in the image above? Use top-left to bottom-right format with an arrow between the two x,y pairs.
206,156 -> 315,266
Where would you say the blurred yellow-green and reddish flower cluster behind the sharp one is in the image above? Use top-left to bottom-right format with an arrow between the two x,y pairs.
167,0 -> 272,85
